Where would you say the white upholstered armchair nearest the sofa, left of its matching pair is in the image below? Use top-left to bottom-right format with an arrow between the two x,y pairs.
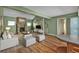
24,34 -> 36,47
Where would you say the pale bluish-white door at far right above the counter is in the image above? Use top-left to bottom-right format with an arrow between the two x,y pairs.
70,17 -> 79,35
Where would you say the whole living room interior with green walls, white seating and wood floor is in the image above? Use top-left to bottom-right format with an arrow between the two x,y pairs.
0,6 -> 79,53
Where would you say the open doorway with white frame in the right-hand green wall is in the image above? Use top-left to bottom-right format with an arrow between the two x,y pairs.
57,18 -> 67,35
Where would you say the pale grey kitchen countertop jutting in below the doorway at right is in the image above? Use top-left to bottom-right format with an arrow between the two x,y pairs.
56,35 -> 79,45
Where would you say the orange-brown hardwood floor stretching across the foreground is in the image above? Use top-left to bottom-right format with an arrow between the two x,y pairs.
0,36 -> 67,53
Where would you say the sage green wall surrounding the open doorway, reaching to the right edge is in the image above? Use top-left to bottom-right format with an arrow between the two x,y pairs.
45,12 -> 78,34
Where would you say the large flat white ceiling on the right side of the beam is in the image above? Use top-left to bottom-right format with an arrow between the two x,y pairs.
24,6 -> 78,17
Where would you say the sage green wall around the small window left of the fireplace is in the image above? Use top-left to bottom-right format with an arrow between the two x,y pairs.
3,16 -> 16,33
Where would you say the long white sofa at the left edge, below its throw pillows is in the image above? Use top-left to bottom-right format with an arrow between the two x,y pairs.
0,35 -> 19,50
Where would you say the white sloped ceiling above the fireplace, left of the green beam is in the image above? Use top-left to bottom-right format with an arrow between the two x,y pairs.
4,8 -> 34,20
